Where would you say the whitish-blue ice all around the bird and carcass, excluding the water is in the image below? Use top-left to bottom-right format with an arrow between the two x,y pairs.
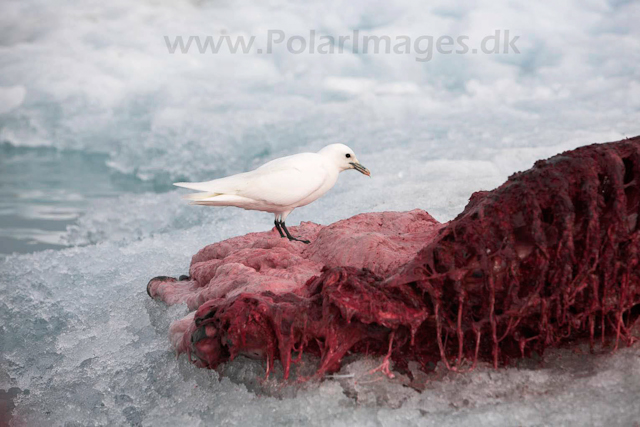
0,0 -> 640,426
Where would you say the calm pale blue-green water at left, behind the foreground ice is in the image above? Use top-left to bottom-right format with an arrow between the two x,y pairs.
0,143 -> 162,254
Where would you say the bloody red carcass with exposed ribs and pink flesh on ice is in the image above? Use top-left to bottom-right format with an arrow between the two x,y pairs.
148,137 -> 640,376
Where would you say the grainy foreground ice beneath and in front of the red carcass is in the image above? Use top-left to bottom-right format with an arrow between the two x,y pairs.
0,234 -> 640,426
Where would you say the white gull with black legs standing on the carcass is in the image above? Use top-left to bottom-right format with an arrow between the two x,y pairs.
173,144 -> 371,243
